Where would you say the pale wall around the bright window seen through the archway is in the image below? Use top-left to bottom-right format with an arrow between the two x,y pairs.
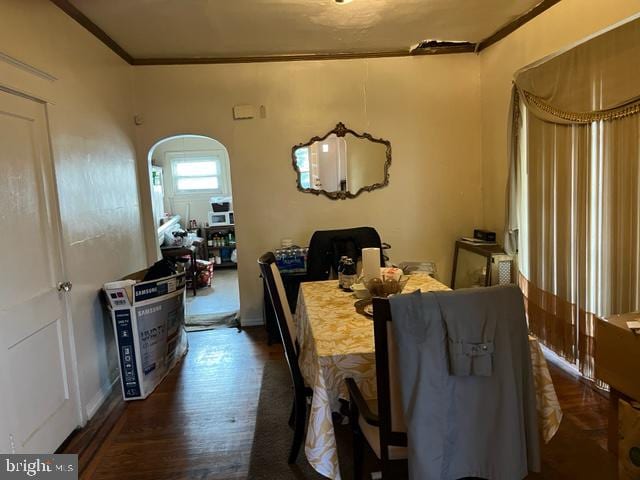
152,137 -> 231,227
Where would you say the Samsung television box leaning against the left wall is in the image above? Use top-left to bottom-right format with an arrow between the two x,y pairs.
104,272 -> 187,400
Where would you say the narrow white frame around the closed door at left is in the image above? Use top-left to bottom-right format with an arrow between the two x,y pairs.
0,82 -> 87,427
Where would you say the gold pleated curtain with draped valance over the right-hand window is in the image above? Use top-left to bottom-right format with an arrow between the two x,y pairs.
505,15 -> 640,378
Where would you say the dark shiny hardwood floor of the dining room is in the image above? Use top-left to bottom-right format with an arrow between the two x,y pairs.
61,327 -> 608,480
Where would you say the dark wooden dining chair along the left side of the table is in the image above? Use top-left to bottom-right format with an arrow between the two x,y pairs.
258,252 -> 312,463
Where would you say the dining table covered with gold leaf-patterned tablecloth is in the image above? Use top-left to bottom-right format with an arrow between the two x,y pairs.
294,273 -> 562,480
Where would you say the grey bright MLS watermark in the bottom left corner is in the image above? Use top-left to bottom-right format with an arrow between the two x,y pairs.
0,454 -> 78,480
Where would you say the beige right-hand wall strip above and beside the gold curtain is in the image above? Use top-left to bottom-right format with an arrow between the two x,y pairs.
480,0 -> 640,239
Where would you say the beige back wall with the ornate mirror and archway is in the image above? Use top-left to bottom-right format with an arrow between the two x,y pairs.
134,54 -> 482,323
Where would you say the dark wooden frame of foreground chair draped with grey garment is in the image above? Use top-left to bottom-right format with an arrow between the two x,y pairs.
346,297 -> 408,480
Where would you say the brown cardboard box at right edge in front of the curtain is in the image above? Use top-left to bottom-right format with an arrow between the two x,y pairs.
595,313 -> 640,400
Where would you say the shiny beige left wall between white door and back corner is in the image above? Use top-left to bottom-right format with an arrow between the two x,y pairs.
0,0 -> 146,420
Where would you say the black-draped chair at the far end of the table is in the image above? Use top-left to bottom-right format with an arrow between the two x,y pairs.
307,227 -> 388,281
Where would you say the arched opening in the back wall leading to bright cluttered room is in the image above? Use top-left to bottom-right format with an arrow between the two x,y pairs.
148,134 -> 240,330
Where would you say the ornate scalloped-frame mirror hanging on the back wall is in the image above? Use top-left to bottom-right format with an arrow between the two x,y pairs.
292,123 -> 391,200
